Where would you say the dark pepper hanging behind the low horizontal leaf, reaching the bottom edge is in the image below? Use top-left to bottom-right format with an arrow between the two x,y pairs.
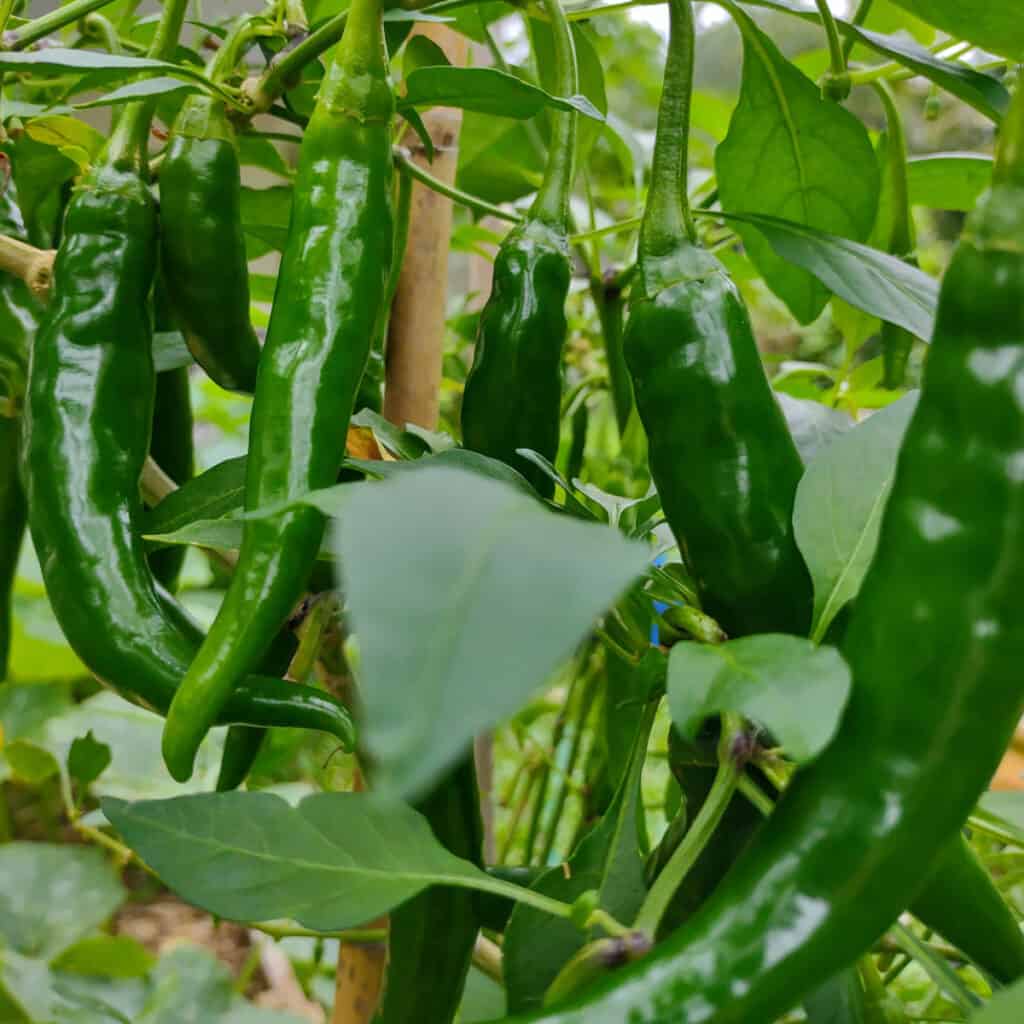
379,755 -> 483,1024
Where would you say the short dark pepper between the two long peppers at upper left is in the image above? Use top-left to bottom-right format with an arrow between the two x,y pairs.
160,95 -> 260,392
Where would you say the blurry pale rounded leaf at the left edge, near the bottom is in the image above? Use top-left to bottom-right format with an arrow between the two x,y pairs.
0,843 -> 125,961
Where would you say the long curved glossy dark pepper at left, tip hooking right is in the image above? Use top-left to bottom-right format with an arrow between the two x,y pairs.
24,165 -> 353,746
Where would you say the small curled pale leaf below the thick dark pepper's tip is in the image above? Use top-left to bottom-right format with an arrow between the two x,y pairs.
669,635 -> 850,764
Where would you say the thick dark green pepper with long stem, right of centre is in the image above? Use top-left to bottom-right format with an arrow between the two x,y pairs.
624,0 -> 811,636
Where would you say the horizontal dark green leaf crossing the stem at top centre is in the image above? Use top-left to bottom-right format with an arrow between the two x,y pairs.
398,67 -> 604,122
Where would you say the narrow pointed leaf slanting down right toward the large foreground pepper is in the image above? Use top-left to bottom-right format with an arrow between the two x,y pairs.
718,213 -> 939,340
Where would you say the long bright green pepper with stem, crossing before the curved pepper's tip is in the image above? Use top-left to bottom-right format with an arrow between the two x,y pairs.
163,0 -> 394,779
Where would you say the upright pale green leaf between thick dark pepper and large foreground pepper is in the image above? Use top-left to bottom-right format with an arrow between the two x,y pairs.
794,394 -> 918,638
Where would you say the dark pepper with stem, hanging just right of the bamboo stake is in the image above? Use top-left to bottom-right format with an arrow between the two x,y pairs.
462,0 -> 579,496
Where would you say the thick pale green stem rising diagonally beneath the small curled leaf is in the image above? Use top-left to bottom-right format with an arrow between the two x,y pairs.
635,715 -> 743,936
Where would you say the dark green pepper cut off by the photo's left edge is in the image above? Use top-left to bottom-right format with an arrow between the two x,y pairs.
0,175 -> 38,681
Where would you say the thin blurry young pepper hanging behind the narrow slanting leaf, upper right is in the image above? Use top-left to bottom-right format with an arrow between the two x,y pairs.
873,82 -> 918,389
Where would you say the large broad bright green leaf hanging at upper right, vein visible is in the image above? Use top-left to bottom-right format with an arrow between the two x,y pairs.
715,2 -> 880,324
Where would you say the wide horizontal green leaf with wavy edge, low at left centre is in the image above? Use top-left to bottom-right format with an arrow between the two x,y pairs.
102,793 -> 501,931
